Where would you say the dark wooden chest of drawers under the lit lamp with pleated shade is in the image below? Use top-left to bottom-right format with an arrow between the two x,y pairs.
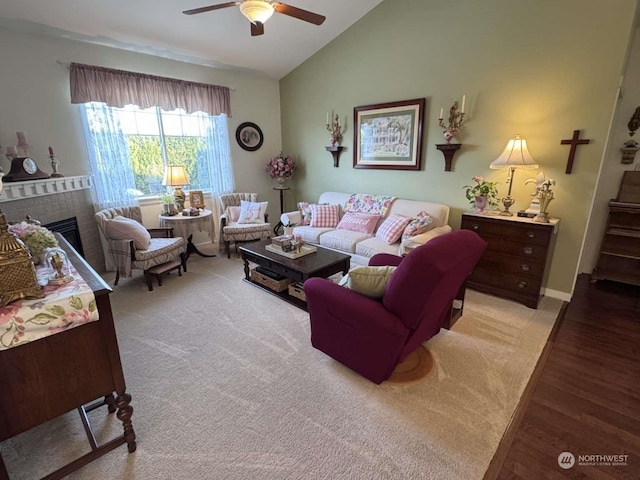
461,213 -> 559,308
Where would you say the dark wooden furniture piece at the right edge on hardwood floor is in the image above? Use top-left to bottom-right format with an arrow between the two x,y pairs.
591,200 -> 640,285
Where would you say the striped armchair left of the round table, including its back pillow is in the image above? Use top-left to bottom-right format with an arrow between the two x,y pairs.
94,206 -> 187,291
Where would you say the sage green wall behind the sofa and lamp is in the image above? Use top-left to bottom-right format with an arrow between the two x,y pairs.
280,0 -> 636,294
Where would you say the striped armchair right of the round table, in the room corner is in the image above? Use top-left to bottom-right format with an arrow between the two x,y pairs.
220,193 -> 271,258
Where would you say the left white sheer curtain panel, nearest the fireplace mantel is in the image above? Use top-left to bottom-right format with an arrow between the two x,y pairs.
81,102 -> 137,211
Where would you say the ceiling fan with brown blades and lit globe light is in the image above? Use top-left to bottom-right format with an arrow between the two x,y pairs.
182,0 -> 326,37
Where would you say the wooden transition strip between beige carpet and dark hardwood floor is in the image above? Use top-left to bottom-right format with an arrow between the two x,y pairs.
483,298 -> 569,480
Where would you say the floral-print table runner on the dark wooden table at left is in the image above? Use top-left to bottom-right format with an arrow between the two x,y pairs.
0,265 -> 98,350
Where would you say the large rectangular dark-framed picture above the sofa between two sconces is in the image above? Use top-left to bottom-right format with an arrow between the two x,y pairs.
353,98 -> 425,170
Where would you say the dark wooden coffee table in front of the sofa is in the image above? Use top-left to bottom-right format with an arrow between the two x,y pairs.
240,239 -> 351,310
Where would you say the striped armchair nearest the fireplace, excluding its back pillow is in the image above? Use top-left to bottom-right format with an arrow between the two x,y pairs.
94,206 -> 187,291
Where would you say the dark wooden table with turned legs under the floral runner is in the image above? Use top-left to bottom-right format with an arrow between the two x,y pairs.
0,234 -> 136,480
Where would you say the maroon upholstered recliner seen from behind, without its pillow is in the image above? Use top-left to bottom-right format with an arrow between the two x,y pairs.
304,230 -> 487,383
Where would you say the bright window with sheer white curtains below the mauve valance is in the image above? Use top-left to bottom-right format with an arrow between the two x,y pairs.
82,102 -> 233,206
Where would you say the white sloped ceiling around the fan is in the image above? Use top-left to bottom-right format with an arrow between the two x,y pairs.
0,0 -> 382,79
